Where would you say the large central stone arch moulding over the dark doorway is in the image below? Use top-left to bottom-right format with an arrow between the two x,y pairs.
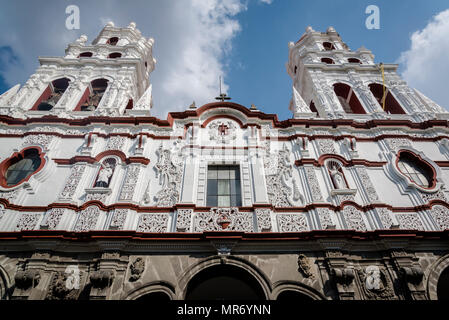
178,256 -> 271,299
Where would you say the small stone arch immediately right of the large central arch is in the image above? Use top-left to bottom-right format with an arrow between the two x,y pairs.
272,281 -> 327,301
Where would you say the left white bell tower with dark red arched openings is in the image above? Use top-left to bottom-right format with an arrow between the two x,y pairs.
0,22 -> 156,118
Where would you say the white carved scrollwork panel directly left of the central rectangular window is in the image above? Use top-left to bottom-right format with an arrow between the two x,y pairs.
155,144 -> 183,207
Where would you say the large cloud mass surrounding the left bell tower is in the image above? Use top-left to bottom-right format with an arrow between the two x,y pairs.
0,0 -> 247,117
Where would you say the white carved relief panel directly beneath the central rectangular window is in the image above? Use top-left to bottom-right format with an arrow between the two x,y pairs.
194,208 -> 254,232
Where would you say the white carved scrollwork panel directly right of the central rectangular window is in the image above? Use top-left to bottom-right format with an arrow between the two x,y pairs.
264,144 -> 302,207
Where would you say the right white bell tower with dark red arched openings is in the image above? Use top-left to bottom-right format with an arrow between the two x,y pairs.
286,27 -> 448,122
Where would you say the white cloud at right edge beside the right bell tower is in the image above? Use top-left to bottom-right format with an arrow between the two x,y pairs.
399,9 -> 449,108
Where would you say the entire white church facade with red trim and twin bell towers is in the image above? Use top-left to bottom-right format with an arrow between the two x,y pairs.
0,23 -> 449,301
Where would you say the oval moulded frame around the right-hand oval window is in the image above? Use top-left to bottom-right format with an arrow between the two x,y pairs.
393,149 -> 441,193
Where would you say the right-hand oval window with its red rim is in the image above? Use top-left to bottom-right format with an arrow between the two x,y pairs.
396,150 -> 436,189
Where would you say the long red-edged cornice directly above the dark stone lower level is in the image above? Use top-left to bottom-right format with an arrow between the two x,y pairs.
0,230 -> 449,242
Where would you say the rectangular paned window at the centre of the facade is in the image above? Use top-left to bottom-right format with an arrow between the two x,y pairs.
207,165 -> 242,207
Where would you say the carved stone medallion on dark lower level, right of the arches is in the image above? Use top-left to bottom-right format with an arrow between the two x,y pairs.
358,265 -> 395,300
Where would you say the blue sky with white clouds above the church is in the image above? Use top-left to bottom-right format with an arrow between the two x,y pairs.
0,0 -> 449,120
